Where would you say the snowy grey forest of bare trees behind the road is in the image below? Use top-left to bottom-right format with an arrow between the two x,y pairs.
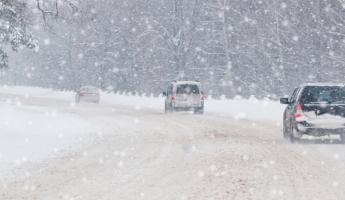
0,0 -> 345,99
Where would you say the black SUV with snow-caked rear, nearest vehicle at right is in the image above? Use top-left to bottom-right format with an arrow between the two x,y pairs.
280,84 -> 345,143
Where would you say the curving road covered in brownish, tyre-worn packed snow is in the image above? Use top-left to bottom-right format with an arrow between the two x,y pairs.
0,88 -> 345,200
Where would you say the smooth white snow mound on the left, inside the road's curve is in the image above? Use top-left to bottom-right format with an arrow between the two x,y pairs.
0,102 -> 93,175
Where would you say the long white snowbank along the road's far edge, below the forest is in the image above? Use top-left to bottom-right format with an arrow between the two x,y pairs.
0,86 -> 285,122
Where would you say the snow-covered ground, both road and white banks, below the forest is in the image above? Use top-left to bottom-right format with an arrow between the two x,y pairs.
0,87 -> 345,200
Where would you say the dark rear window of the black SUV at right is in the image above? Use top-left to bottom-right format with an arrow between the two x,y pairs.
301,86 -> 345,104
